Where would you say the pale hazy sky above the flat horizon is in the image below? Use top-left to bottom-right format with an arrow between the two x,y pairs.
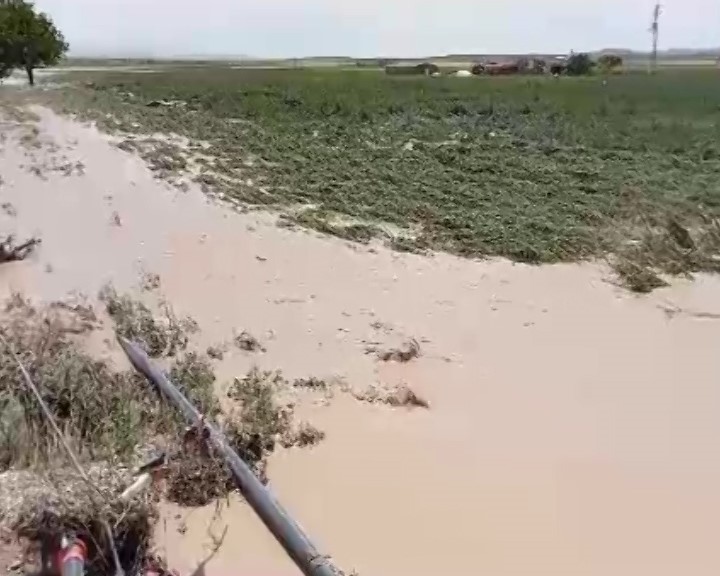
36,0 -> 720,57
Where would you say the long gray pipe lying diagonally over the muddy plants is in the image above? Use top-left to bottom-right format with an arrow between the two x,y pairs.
118,337 -> 341,576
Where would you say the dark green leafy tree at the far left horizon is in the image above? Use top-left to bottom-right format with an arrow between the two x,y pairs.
0,0 -> 68,86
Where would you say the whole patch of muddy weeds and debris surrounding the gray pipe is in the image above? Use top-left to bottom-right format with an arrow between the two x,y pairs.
0,289 -> 322,575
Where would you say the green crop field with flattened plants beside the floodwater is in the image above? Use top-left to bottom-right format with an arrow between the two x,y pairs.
49,67 -> 720,291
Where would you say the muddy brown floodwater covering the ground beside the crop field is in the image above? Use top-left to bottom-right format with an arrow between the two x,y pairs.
0,106 -> 720,576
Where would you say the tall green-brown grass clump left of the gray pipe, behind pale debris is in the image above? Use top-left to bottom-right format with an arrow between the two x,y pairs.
0,299 -> 160,469
